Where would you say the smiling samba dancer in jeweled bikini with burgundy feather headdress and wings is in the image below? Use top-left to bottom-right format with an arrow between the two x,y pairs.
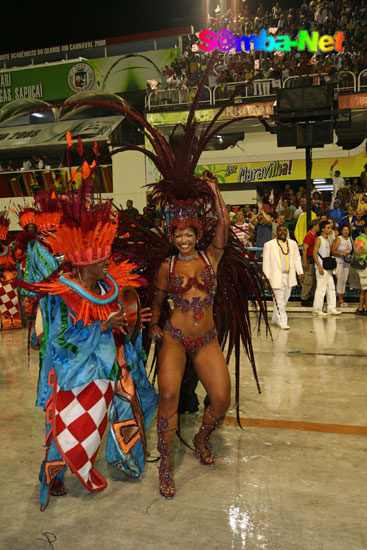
108,71 -> 267,498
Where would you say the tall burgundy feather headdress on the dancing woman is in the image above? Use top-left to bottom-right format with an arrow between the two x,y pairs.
100,54 -> 256,237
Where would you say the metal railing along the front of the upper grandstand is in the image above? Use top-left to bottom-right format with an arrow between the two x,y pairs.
145,69 -> 367,111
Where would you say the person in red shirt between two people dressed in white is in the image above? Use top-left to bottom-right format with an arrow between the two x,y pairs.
301,220 -> 320,306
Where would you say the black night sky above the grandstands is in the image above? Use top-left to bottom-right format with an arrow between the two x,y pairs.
0,0 -> 301,53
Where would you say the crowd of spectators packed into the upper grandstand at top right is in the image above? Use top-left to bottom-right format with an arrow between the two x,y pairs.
149,0 -> 367,102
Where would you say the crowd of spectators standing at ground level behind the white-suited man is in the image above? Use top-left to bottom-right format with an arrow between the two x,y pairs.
231,164 -> 367,315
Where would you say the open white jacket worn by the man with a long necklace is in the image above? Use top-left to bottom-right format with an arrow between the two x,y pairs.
263,239 -> 303,288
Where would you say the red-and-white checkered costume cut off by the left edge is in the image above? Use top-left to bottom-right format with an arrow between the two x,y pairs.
0,211 -> 22,330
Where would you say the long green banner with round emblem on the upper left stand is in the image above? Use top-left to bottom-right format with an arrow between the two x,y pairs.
0,48 -> 180,106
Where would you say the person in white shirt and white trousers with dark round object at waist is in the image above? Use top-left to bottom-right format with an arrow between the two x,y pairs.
313,221 -> 341,317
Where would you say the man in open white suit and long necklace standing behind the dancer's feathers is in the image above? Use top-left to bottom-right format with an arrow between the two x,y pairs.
263,225 -> 303,329
